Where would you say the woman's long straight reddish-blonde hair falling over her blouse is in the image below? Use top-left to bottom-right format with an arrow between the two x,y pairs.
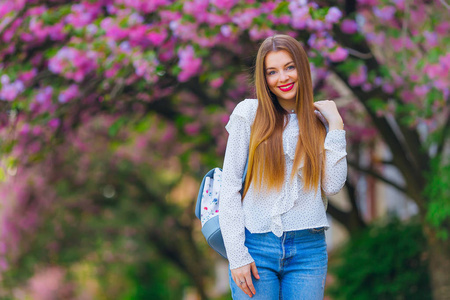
242,35 -> 326,199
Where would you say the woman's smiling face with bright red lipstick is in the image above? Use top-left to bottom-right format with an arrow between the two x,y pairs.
264,50 -> 298,110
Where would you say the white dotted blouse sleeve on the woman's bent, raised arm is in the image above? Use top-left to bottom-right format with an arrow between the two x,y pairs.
322,130 -> 347,196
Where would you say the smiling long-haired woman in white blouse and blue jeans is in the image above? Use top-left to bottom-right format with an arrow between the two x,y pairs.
219,35 -> 347,300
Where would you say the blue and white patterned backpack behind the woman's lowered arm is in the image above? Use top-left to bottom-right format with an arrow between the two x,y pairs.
195,160 -> 248,258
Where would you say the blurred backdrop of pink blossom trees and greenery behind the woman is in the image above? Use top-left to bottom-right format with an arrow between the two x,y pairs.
0,0 -> 450,300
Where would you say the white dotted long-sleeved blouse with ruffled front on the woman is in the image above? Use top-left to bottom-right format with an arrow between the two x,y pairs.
219,99 -> 347,269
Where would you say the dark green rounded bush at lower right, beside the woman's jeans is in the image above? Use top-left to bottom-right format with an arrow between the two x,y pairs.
328,219 -> 432,300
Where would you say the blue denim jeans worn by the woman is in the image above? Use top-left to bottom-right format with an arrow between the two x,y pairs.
228,227 -> 328,300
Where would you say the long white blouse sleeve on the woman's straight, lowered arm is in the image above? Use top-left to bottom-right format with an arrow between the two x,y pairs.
219,114 -> 253,269
